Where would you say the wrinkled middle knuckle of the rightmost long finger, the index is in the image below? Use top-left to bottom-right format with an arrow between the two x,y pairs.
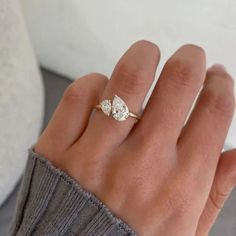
202,88 -> 235,115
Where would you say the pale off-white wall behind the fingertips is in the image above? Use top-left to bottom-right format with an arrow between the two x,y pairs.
20,0 -> 236,146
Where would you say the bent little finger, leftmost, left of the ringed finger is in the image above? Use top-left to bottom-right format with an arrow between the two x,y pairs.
35,73 -> 108,161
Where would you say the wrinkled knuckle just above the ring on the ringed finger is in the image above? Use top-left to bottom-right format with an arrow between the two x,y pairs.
115,62 -> 145,94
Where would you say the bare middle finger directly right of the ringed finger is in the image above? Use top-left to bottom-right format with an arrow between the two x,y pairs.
138,45 -> 206,143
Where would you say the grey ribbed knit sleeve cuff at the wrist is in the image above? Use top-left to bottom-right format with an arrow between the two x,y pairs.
10,149 -> 136,236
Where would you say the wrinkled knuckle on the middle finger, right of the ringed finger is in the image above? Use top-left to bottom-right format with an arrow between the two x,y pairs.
166,57 -> 198,87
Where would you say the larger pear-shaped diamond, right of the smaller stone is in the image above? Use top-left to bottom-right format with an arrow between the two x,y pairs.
112,95 -> 129,121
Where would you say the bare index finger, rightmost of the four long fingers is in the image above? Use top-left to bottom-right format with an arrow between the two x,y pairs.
178,66 -> 235,176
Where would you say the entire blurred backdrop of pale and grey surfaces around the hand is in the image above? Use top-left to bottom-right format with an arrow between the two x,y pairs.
0,0 -> 236,236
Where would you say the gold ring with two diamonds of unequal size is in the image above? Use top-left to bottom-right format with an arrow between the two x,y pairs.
95,95 -> 141,121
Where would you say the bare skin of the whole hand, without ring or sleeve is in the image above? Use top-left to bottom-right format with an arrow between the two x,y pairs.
35,41 -> 236,236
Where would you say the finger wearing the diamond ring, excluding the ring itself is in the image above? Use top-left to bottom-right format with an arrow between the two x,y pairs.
75,41 -> 160,154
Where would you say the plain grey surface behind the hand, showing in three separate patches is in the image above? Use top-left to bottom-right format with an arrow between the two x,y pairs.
0,70 -> 236,236
